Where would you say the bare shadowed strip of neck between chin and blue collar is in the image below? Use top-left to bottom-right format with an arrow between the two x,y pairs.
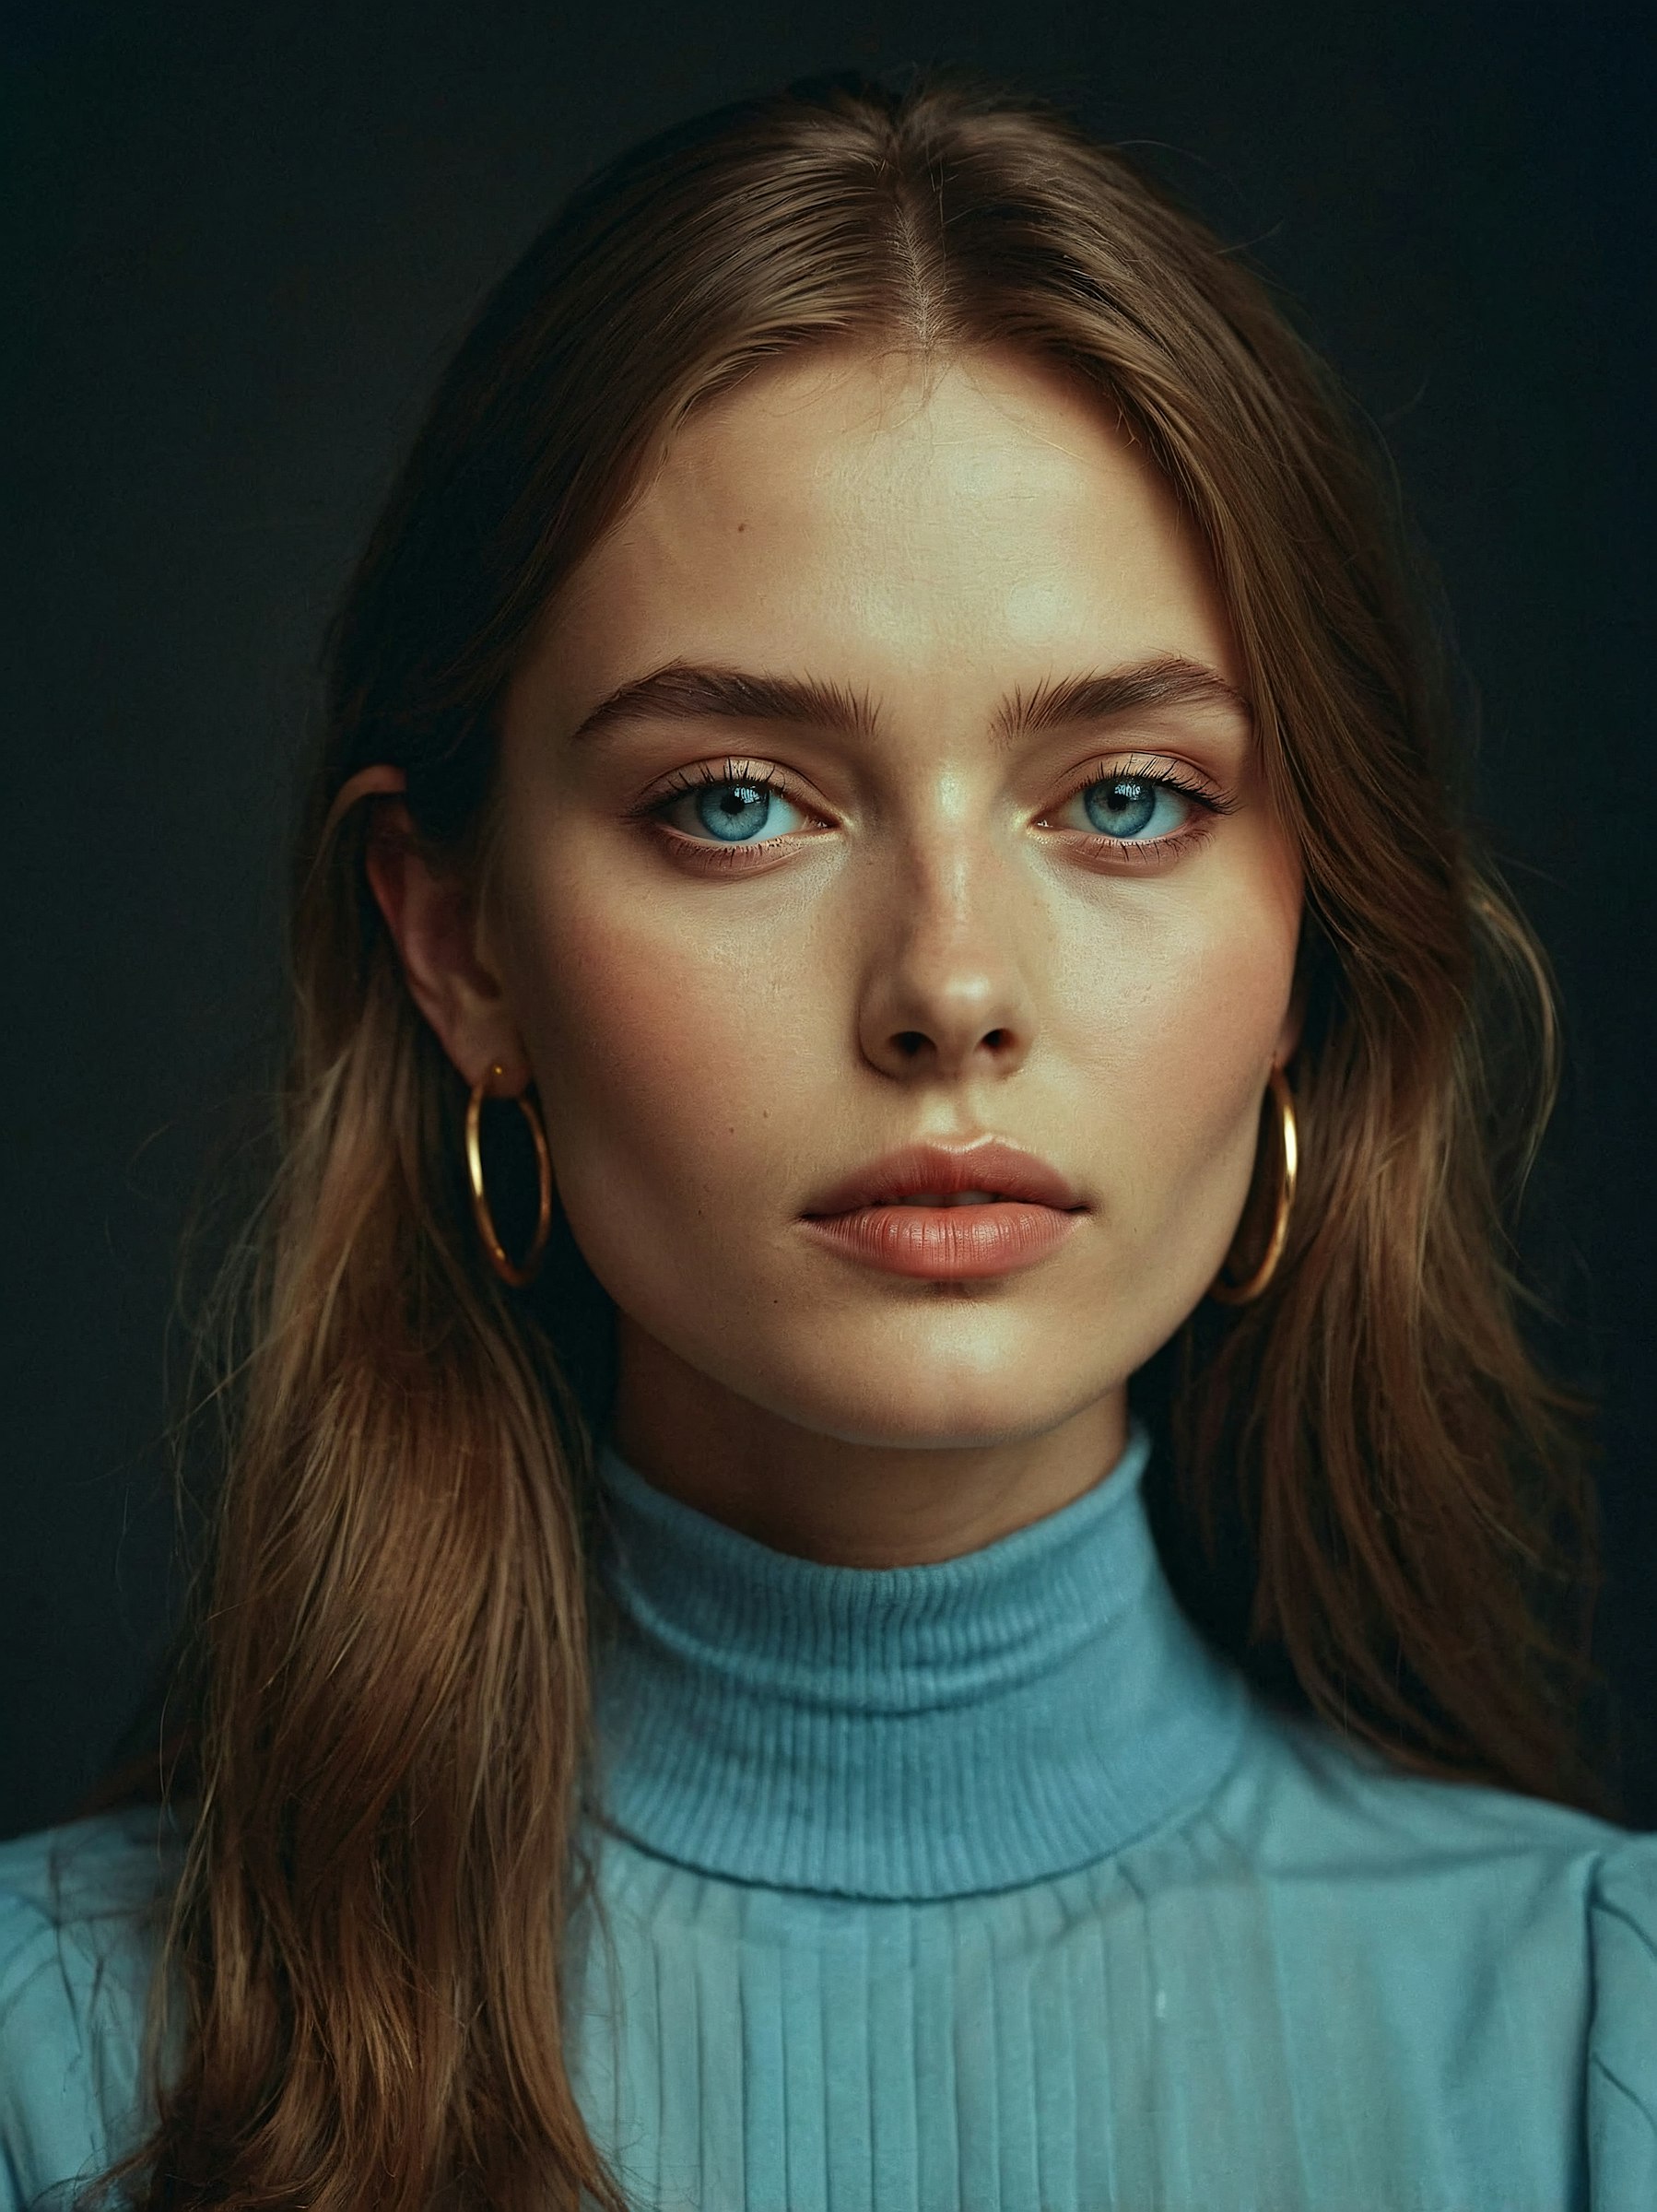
611,1316 -> 1128,1566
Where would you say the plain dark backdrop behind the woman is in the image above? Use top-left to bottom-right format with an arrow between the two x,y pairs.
0,0 -> 1657,1834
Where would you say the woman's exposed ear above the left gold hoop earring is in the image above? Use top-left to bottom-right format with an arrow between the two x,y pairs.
365,798 -> 529,1097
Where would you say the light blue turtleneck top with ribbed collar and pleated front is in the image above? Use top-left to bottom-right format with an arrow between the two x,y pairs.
0,1427 -> 1657,2212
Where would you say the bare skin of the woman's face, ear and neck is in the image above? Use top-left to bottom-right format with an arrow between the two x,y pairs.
371,352 -> 1301,1566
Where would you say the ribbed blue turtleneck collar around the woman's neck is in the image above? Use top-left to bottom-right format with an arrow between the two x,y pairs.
579,1422 -> 1243,1898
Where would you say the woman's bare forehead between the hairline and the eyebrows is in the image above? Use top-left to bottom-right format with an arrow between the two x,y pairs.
523,349 -> 1234,708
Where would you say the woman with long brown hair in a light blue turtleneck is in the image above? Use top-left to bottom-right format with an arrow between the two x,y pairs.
0,69 -> 1657,2212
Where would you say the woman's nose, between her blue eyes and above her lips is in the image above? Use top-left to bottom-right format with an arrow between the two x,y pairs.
858,830 -> 1035,1079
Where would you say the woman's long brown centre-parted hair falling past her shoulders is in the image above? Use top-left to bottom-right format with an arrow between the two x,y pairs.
87,77 -> 1592,2212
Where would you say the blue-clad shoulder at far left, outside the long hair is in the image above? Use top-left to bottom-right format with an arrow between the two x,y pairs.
0,1807 -> 182,2206
